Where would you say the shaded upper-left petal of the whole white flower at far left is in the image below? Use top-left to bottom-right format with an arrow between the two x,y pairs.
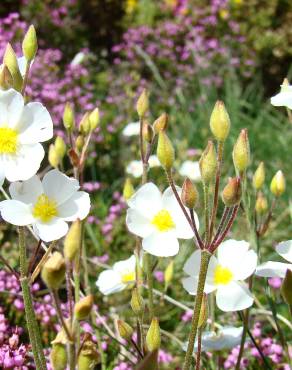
9,175 -> 43,204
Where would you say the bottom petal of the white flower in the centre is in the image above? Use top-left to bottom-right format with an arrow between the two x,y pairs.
142,231 -> 179,257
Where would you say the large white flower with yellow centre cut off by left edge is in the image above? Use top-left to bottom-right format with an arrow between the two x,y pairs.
0,89 -> 53,181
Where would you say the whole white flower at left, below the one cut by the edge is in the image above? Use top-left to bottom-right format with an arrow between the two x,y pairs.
0,170 -> 90,242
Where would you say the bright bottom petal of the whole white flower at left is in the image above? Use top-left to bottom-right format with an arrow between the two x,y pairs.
33,218 -> 68,242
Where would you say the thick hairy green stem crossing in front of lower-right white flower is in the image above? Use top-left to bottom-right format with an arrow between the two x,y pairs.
183,250 -> 211,370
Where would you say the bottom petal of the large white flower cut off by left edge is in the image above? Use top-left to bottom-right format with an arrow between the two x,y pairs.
1,144 -> 45,182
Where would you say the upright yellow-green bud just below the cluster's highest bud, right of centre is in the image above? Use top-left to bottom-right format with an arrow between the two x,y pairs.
199,140 -> 217,185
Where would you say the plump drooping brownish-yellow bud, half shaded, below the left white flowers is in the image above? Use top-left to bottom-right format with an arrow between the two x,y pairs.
41,252 -> 66,290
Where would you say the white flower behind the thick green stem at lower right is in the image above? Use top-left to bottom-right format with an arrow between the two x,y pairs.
183,239 -> 257,312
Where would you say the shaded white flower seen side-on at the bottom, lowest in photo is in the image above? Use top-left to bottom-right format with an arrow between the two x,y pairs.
183,326 -> 243,352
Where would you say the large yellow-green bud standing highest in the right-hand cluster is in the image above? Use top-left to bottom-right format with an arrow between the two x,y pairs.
210,100 -> 230,142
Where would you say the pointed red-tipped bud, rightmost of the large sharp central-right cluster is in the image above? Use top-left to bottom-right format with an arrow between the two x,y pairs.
233,129 -> 250,174
